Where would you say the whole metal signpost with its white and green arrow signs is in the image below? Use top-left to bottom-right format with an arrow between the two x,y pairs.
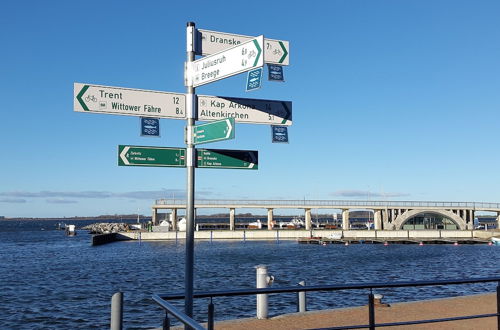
74,22 -> 292,324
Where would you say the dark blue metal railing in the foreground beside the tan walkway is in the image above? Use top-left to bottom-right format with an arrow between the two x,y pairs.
153,277 -> 500,330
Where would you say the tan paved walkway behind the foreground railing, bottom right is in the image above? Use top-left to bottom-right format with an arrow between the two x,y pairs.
215,294 -> 497,330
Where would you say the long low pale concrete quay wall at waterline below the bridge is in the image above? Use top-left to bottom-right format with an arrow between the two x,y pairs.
116,230 -> 500,241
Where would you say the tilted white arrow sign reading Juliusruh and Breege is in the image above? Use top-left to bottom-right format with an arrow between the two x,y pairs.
186,36 -> 264,87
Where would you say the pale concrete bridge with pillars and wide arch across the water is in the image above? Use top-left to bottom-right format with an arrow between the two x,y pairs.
152,199 -> 500,230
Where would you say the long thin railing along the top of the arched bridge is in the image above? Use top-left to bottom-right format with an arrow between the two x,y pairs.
155,199 -> 500,211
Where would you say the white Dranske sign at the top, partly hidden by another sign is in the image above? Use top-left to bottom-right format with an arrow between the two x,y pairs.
196,30 -> 290,65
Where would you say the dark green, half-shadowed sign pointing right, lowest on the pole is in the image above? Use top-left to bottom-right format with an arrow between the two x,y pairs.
197,149 -> 259,170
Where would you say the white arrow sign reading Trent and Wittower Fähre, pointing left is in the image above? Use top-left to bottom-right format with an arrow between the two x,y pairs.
74,83 -> 186,119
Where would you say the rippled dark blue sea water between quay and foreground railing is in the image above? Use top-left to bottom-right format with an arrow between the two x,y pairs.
0,221 -> 500,329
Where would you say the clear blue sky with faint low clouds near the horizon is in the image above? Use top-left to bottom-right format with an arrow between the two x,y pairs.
0,0 -> 500,217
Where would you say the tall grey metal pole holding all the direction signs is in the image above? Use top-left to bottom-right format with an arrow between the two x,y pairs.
184,22 -> 198,317
